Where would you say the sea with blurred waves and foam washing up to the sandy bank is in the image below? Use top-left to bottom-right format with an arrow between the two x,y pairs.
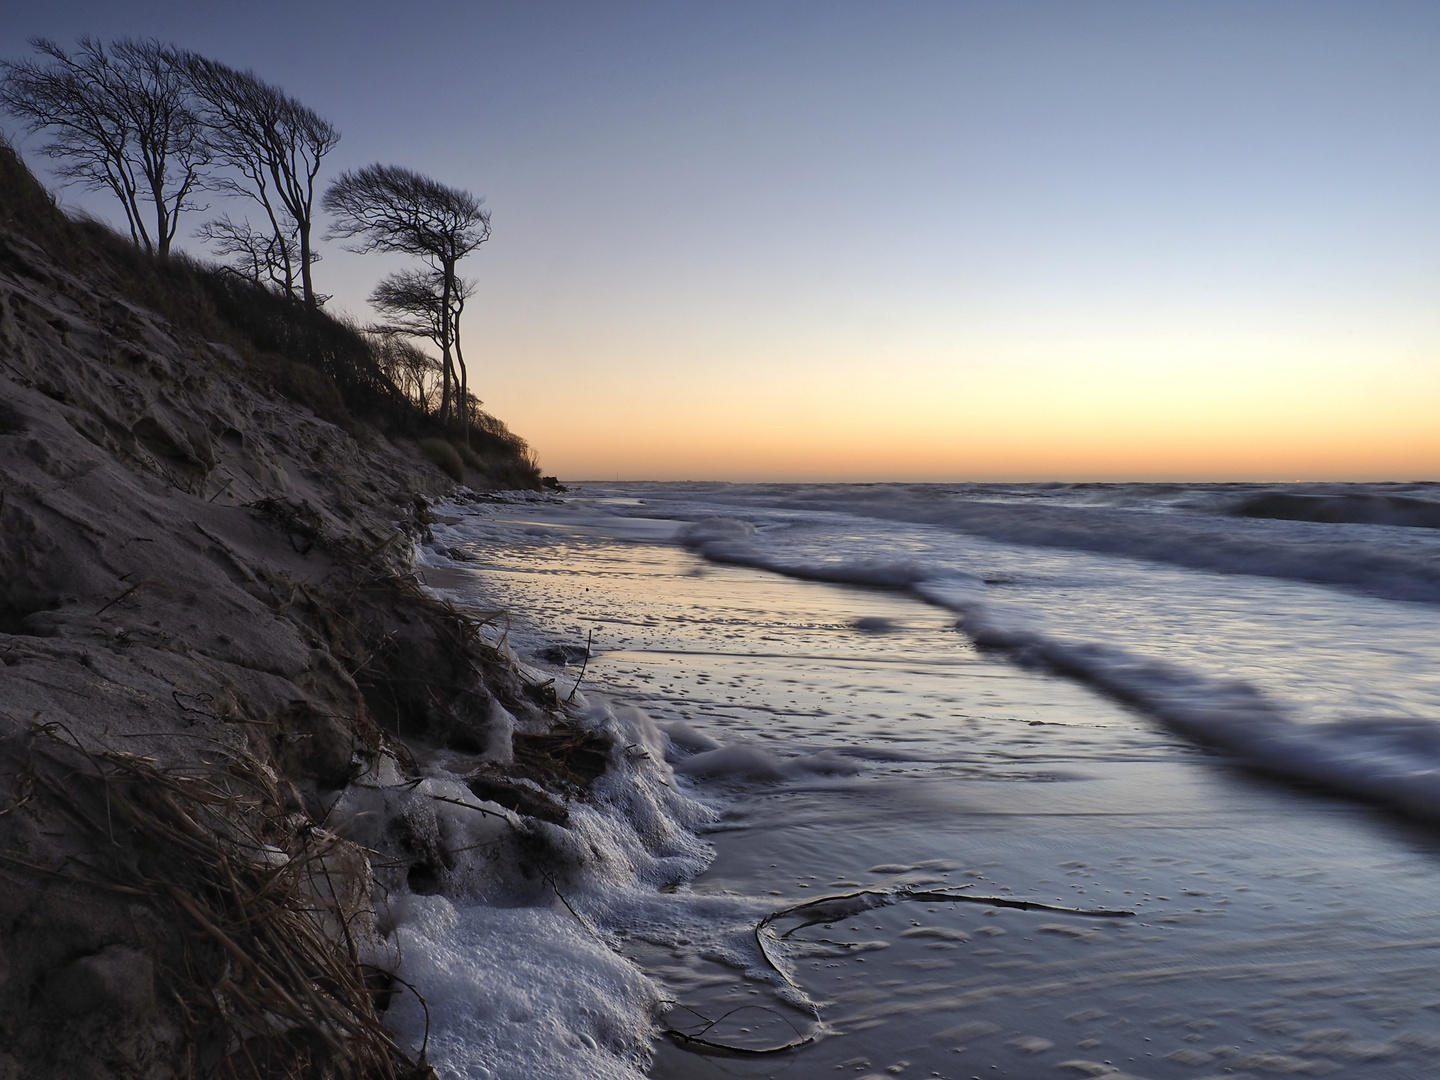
368,482 -> 1440,1080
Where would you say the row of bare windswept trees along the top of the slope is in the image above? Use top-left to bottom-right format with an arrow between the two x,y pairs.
0,37 -> 490,432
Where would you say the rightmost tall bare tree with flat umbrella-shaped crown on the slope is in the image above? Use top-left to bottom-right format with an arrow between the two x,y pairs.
321,166 -> 490,423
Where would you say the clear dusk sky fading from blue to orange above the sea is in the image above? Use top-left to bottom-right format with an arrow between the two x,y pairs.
0,0 -> 1440,481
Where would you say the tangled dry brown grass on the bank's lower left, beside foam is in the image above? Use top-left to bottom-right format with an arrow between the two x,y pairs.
0,726 -> 433,1080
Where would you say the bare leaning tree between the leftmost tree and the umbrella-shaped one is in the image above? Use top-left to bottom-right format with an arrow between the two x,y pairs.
180,52 -> 340,307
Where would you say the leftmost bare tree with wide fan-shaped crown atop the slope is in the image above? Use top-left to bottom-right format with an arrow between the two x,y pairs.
0,37 -> 210,259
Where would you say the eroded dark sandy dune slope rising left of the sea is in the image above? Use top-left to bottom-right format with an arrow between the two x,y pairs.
0,151 -> 612,1080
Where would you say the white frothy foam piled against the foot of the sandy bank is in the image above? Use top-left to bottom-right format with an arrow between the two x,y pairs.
330,696 -> 755,1080
